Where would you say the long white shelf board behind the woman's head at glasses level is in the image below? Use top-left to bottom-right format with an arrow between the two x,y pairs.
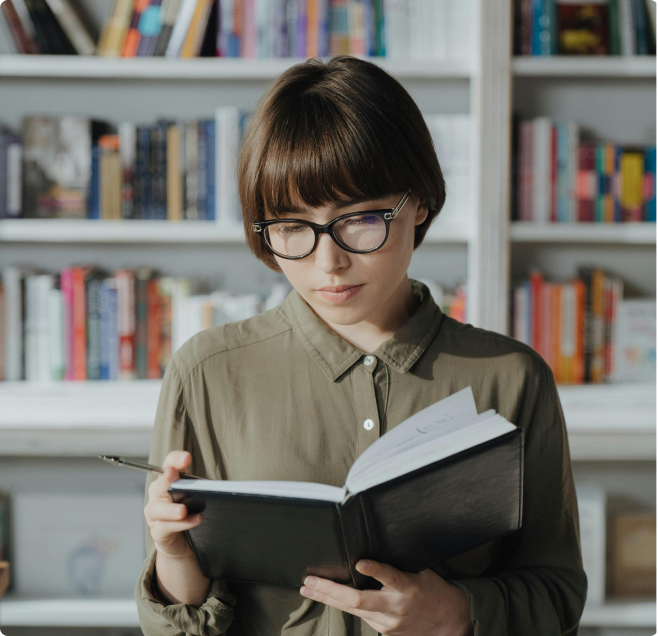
0,219 -> 470,245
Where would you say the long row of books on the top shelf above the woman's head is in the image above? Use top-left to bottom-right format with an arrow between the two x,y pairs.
0,0 -> 476,61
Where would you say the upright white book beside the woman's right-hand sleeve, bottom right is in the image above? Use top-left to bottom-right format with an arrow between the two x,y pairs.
576,484 -> 606,606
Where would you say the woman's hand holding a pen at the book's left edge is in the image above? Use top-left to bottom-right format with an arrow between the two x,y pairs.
144,451 -> 203,559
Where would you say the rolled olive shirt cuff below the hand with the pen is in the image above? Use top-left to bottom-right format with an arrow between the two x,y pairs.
140,550 -> 236,636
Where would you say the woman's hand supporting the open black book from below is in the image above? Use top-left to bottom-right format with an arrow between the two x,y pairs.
300,561 -> 473,636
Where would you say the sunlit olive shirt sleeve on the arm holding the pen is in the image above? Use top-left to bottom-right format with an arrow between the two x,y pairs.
135,360 -> 235,636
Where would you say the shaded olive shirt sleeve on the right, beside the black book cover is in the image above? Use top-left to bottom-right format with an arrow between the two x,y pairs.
452,363 -> 587,636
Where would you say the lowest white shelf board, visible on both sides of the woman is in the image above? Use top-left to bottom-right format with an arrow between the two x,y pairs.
0,597 -> 657,629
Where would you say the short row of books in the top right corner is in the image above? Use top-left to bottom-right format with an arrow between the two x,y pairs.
514,0 -> 656,56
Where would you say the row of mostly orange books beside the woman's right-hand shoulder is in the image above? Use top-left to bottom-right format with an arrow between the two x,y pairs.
510,267 -> 656,384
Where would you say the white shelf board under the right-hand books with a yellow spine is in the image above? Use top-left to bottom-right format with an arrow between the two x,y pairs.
510,221 -> 658,245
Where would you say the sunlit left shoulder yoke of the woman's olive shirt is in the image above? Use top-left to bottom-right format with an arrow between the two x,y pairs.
172,307 -> 291,382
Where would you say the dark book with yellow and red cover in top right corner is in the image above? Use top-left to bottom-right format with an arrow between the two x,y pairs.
557,0 -> 610,55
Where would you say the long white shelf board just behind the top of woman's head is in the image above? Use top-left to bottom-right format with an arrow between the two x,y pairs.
0,55 -> 473,80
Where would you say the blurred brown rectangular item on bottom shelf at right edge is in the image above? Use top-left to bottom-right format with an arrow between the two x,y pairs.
611,512 -> 658,600
